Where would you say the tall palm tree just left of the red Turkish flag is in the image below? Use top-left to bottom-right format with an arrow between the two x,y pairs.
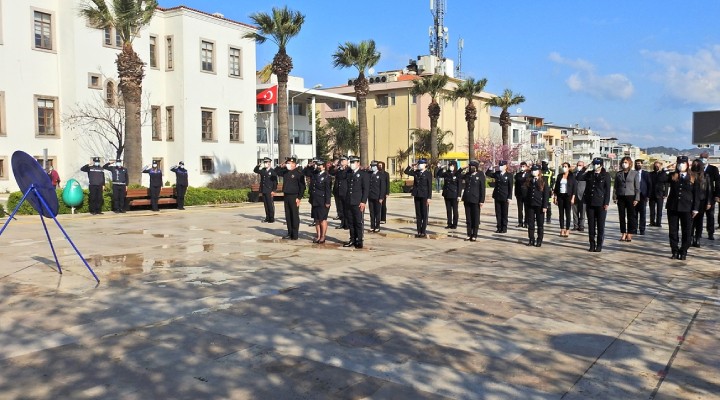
243,6 -> 305,160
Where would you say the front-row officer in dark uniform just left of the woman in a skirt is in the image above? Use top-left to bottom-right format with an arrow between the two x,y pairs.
275,157 -> 305,240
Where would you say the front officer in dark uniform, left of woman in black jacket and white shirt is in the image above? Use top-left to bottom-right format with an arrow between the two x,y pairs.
524,165 -> 550,247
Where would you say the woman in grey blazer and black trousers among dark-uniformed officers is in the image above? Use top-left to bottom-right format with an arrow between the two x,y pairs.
613,157 -> 640,242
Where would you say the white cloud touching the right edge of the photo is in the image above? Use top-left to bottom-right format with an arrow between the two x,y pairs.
641,45 -> 720,105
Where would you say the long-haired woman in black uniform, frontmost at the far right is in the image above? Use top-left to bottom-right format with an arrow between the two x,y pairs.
665,156 -> 700,260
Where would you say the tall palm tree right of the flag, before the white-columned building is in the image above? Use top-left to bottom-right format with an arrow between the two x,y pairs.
332,39 -> 380,165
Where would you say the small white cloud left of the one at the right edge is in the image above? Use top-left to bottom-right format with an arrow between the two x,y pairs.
549,52 -> 635,100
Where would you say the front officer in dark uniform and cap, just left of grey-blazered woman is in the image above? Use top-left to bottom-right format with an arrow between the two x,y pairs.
578,157 -> 611,253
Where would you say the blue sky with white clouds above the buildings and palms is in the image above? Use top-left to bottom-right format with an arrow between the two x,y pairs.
160,0 -> 720,149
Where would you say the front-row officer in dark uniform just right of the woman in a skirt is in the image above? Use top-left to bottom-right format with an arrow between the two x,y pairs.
343,157 -> 370,249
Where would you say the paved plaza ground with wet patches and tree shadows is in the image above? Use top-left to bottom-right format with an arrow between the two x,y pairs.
0,195 -> 720,399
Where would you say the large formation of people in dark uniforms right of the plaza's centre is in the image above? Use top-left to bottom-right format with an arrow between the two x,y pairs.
254,152 -> 720,260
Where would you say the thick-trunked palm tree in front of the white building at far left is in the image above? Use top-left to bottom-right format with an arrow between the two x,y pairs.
80,0 -> 158,184
